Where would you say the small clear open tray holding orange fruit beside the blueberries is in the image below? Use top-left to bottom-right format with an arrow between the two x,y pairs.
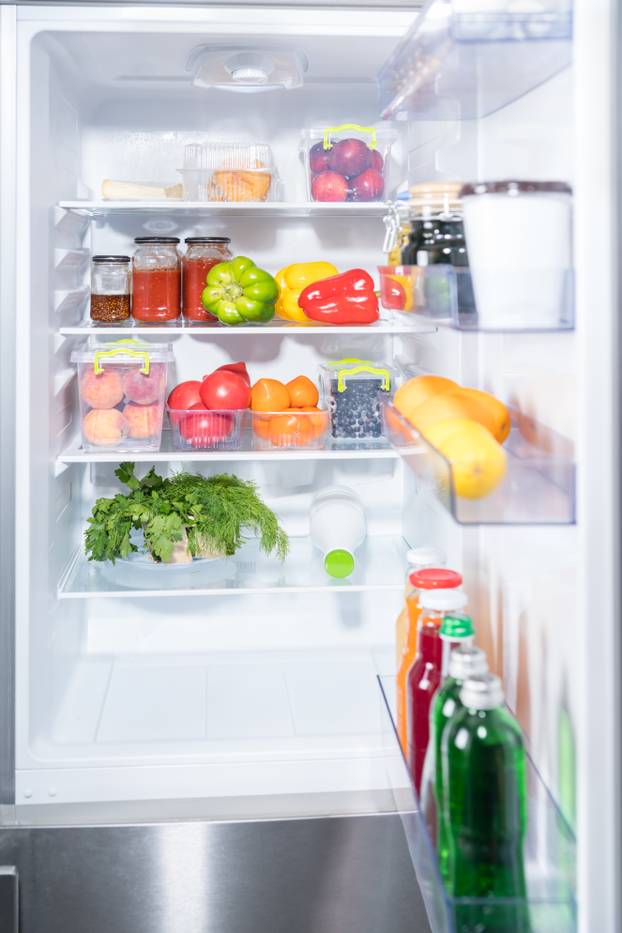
251,409 -> 330,450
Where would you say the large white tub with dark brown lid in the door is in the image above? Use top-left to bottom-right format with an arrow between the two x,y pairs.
461,181 -> 572,330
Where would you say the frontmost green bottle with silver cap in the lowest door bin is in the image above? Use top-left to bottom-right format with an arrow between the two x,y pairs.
441,674 -> 529,933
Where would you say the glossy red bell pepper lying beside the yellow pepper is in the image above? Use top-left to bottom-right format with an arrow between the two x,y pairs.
298,269 -> 378,325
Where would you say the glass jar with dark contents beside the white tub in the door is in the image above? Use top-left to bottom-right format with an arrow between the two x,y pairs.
402,182 -> 475,314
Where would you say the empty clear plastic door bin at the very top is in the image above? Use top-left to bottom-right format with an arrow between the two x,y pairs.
379,0 -> 572,120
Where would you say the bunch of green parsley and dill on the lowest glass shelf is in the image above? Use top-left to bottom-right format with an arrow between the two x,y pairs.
84,463 -> 289,563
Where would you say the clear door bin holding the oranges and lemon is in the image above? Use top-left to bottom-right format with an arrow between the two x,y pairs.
384,402 -> 575,525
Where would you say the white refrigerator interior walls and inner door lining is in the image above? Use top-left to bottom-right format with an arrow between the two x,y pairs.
16,0 -> 578,868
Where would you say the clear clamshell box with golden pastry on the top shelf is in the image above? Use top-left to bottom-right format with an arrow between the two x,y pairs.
179,142 -> 279,201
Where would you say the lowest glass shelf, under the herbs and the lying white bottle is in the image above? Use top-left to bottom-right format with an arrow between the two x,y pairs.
58,535 -> 408,599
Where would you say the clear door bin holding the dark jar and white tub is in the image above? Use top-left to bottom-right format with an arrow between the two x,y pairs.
378,265 -> 574,333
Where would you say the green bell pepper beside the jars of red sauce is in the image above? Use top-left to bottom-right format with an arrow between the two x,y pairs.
201,256 -> 279,325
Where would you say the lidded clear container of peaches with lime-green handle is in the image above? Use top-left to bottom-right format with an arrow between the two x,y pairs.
71,338 -> 174,452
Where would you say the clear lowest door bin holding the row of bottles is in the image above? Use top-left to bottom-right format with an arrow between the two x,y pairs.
378,677 -> 576,933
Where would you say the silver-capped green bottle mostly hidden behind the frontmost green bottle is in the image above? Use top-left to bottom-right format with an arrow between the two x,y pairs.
430,645 -> 488,883
